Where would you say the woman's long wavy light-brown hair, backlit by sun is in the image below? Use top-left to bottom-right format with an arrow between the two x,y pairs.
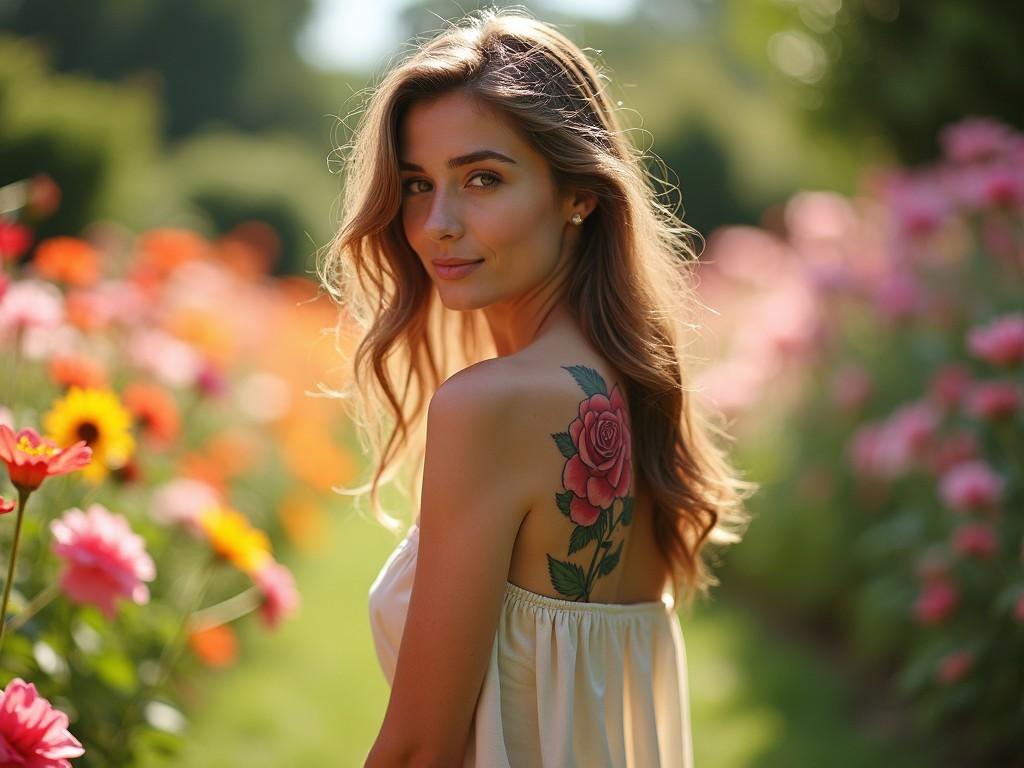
317,4 -> 757,606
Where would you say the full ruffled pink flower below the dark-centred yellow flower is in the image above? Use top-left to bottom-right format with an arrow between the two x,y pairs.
50,504 -> 157,618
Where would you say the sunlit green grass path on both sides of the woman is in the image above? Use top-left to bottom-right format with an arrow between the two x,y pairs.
143,505 -> 926,768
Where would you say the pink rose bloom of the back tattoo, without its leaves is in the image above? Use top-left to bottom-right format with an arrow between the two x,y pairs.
562,384 -> 632,525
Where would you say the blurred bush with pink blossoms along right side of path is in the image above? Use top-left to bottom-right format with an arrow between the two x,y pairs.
700,118 -> 1024,765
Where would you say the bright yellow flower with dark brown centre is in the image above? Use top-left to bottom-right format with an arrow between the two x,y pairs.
43,386 -> 135,484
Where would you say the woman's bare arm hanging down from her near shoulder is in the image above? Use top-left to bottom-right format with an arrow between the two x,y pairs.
375,372 -> 526,765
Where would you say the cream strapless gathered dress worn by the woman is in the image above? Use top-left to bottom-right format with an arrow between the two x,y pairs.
370,525 -> 693,768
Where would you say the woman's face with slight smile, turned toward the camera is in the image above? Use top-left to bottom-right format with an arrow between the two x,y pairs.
398,91 -> 573,309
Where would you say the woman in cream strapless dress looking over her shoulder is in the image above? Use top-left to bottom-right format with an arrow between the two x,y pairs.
319,10 -> 753,767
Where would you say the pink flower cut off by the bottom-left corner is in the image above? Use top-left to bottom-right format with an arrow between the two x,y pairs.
0,677 -> 85,768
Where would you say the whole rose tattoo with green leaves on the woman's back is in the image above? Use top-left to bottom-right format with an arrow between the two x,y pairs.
548,366 -> 633,601
